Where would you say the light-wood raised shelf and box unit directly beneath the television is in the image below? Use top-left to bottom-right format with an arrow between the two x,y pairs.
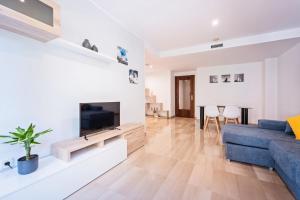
51,123 -> 145,162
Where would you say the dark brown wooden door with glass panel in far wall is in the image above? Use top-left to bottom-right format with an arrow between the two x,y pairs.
175,75 -> 195,118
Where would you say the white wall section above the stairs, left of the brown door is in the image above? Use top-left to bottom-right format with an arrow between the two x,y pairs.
145,71 -> 171,111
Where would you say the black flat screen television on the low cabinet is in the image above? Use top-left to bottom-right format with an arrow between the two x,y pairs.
80,102 -> 120,137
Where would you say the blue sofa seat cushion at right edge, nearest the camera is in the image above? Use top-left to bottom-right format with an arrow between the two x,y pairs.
270,141 -> 300,186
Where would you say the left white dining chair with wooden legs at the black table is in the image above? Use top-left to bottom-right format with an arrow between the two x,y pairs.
204,106 -> 220,137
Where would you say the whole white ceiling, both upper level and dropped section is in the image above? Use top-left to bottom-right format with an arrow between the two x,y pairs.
90,0 -> 300,69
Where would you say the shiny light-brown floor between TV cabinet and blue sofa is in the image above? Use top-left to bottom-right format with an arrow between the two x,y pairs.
68,118 -> 294,200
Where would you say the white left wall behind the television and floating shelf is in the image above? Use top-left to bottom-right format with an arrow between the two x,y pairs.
0,0 -> 144,163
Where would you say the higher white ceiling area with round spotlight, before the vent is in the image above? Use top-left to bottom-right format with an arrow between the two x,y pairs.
94,0 -> 300,51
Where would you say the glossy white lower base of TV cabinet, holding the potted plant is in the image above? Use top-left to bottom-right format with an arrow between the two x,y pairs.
0,138 -> 127,200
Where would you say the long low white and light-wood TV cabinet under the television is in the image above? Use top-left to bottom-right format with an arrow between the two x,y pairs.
0,123 -> 145,200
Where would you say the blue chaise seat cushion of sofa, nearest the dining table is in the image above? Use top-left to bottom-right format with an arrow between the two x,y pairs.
222,125 -> 294,149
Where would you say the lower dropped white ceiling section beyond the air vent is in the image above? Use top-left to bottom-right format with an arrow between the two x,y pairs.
145,38 -> 300,72
